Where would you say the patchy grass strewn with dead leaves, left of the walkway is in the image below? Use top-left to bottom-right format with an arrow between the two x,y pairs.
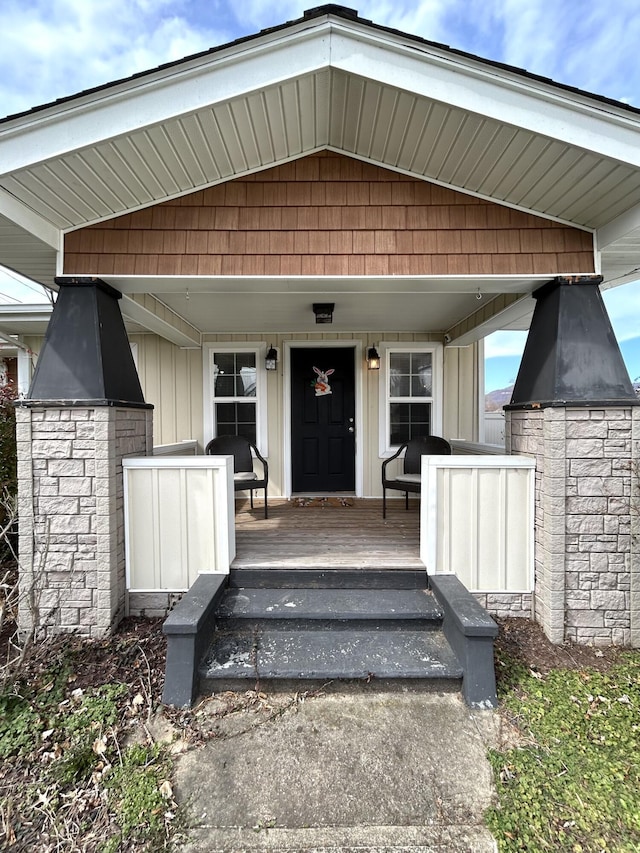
0,658 -> 175,853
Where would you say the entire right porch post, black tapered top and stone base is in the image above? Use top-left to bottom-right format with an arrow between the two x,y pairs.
505,276 -> 640,645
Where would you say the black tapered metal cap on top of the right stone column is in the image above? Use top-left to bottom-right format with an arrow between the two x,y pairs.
506,276 -> 640,408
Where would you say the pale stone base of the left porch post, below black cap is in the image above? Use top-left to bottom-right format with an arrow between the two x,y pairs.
16,403 -> 153,637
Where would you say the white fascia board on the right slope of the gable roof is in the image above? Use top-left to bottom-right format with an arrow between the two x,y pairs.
331,28 -> 640,166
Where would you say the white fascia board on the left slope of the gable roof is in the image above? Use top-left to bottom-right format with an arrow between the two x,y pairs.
0,25 -> 330,175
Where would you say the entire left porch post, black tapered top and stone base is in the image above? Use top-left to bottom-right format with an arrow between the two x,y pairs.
16,279 -> 153,636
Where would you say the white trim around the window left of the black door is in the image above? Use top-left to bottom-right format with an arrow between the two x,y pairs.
202,341 -> 269,456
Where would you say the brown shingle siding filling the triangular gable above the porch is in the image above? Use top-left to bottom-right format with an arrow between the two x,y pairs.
64,152 -> 594,275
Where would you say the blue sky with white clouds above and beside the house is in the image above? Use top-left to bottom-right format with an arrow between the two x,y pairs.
0,0 -> 640,390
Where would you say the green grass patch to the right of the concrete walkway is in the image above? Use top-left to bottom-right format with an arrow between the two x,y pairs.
486,653 -> 640,853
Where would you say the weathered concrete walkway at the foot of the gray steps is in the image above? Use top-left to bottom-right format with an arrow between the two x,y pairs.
175,684 -> 499,853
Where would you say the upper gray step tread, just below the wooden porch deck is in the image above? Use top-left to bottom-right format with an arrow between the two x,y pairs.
217,588 -> 442,621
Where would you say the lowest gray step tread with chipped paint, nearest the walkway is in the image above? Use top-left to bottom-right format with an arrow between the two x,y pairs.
200,626 -> 462,679
